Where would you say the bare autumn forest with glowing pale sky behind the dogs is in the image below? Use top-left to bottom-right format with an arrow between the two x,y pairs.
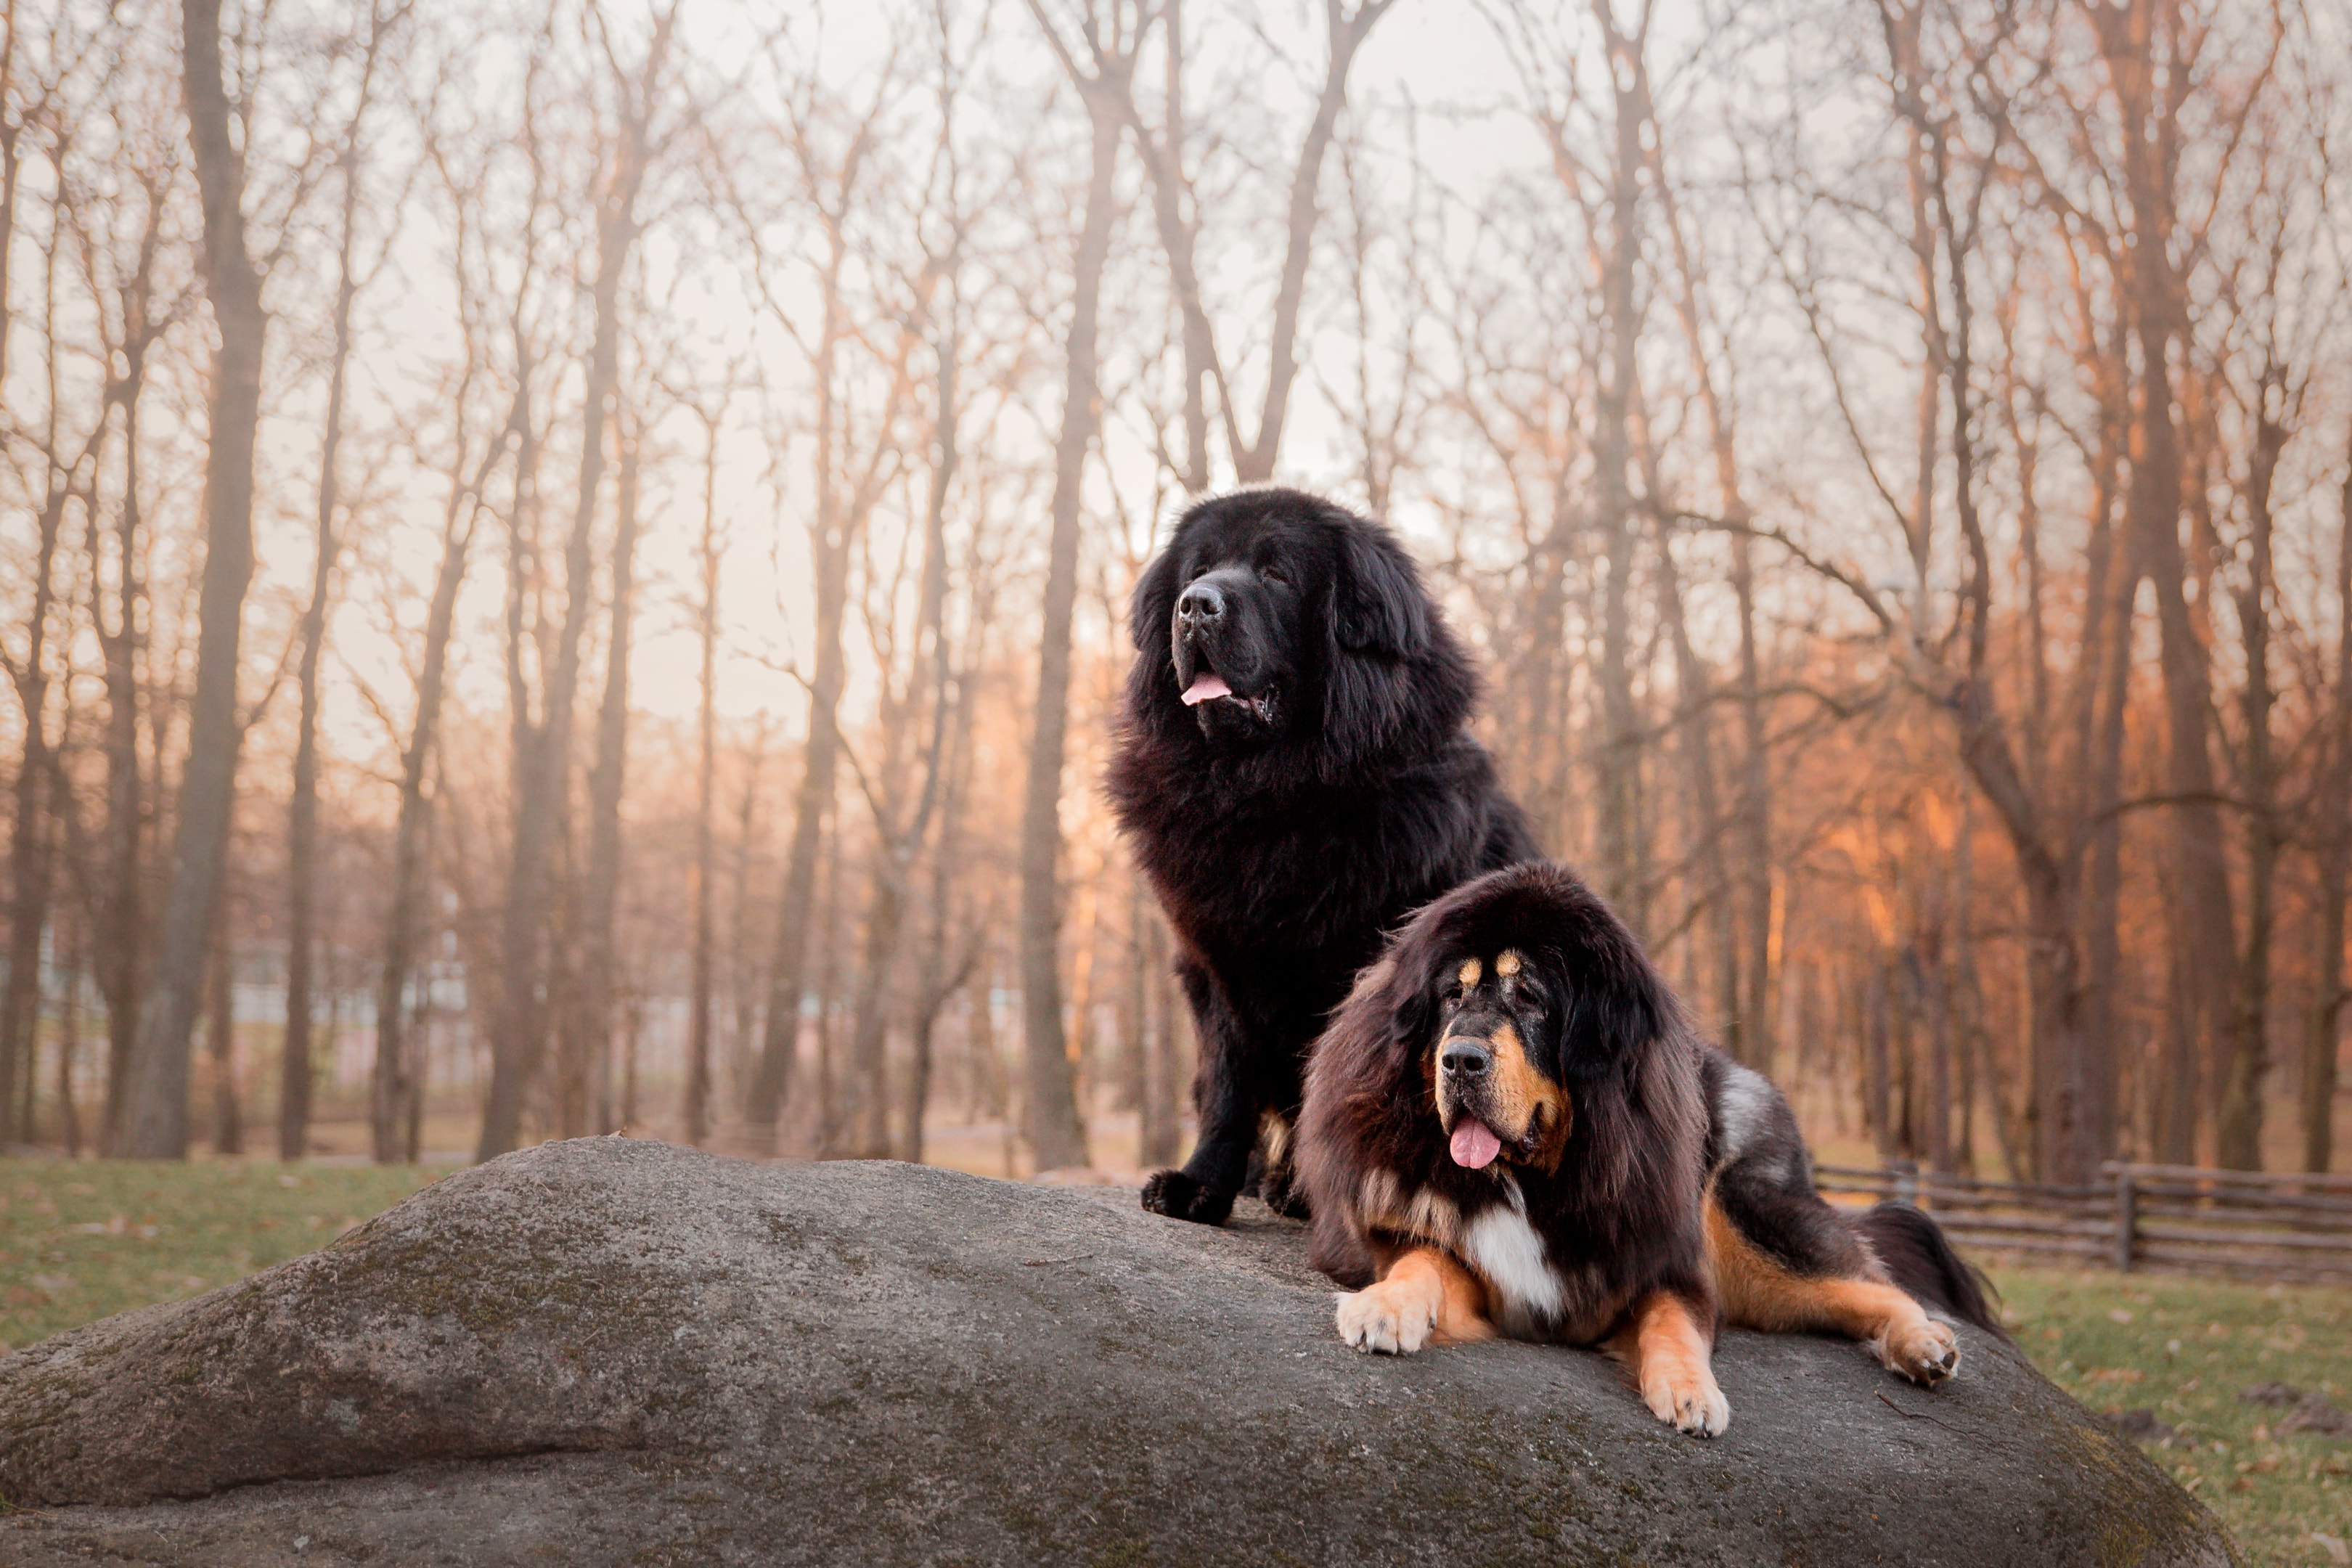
0,0 -> 2352,1183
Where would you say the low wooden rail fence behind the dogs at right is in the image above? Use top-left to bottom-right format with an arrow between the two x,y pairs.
1813,1164 -> 2352,1286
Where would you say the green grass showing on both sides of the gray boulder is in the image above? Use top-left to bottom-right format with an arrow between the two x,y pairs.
0,1161 -> 2352,1568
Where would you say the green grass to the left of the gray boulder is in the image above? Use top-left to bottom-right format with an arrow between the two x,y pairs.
0,1159 -> 435,1354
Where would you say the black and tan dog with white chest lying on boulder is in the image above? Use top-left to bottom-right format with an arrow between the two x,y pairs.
1298,865 -> 2001,1437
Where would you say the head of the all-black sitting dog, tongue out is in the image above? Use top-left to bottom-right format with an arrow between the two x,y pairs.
1129,489 -> 1470,750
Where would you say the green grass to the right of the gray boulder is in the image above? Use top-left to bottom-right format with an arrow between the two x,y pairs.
1995,1270 -> 2352,1568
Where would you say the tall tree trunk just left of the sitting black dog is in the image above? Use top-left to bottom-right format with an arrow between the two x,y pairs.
1021,89 -> 1119,1171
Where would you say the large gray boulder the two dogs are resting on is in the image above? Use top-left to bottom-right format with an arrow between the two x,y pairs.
0,1138 -> 2232,1568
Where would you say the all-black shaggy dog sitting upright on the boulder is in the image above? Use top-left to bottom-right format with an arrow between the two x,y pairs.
1108,489 -> 1538,1225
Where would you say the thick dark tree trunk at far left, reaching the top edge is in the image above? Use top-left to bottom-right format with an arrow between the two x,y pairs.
115,0 -> 268,1159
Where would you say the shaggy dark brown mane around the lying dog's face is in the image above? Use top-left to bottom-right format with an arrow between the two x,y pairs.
1298,862 -> 1715,1344
